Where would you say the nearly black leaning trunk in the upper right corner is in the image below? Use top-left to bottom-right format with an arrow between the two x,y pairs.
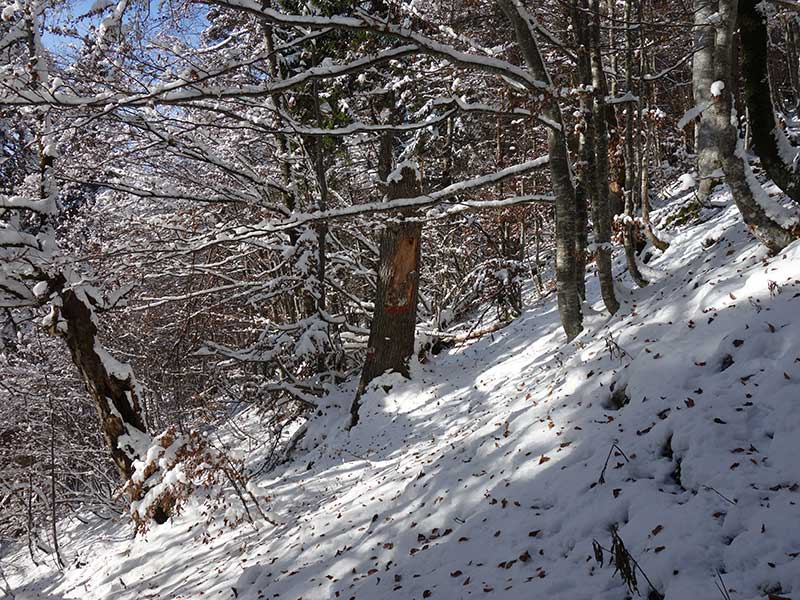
738,0 -> 800,202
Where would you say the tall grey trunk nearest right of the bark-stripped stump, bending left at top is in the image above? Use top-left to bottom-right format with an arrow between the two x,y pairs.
498,0 -> 583,340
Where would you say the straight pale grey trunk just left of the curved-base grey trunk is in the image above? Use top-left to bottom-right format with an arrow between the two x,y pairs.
692,0 -> 721,197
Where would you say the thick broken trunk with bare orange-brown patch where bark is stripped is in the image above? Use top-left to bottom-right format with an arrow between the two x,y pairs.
350,163 -> 422,427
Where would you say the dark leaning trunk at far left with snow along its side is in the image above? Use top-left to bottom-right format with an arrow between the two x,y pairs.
51,275 -> 150,480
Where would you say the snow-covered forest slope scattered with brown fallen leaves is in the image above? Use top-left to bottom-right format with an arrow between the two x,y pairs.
0,185 -> 800,600
